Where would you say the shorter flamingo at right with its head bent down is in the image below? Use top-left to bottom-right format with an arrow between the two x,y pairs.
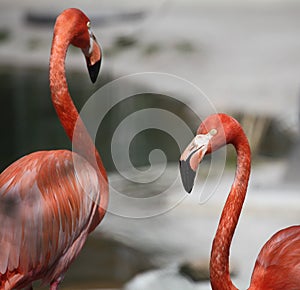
180,114 -> 300,290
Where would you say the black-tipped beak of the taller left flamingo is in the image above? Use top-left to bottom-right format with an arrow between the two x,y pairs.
83,32 -> 102,83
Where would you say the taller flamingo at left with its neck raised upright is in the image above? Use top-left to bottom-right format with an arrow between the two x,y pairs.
0,8 -> 108,290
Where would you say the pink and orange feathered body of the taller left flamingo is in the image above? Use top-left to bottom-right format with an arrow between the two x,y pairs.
0,150 -> 100,289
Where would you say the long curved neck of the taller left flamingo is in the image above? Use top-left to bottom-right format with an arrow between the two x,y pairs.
49,28 -> 108,230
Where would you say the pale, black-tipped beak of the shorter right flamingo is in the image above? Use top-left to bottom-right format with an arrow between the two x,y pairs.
179,133 -> 212,193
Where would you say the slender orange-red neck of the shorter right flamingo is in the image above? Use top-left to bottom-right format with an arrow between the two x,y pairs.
210,130 -> 251,290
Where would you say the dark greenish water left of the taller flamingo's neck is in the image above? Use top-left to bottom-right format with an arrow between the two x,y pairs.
0,68 -> 90,170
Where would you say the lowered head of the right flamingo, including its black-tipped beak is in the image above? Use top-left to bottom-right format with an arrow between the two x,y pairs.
179,114 -> 238,193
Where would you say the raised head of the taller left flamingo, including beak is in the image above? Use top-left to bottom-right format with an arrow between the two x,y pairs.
56,8 -> 102,83
